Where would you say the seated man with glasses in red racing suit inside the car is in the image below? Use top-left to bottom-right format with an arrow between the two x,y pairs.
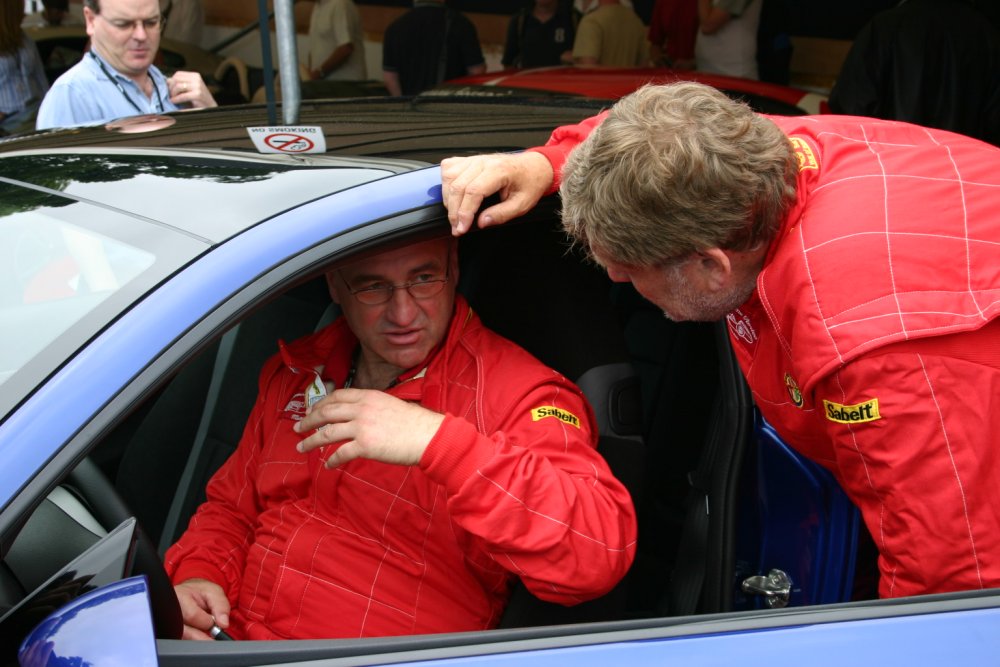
166,239 -> 635,639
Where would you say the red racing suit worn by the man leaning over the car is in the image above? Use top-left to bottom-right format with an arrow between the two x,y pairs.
533,111 -> 1000,597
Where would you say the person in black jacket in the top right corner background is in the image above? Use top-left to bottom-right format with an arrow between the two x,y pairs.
830,0 -> 1000,146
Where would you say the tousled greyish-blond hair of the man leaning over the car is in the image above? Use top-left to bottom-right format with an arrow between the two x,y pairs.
560,82 -> 796,266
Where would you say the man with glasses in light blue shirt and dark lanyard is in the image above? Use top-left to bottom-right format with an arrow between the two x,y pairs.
35,0 -> 216,130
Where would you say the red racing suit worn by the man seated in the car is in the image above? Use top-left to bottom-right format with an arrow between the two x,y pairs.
165,297 -> 635,639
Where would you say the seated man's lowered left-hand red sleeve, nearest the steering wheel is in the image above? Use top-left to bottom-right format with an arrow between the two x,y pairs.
164,359 -> 288,602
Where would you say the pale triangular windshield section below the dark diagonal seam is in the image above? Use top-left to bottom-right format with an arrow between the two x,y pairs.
0,177 -> 208,416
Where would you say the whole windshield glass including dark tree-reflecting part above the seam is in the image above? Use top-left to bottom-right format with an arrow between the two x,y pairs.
0,151 -> 404,419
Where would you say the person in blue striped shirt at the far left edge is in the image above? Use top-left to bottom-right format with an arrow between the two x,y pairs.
0,0 -> 49,133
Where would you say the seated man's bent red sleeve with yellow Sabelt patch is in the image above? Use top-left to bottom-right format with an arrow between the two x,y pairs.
420,381 -> 636,605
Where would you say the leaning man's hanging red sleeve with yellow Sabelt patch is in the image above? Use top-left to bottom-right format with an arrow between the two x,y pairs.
814,345 -> 1000,597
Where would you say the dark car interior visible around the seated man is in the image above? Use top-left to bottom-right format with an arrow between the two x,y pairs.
0,197 -> 752,656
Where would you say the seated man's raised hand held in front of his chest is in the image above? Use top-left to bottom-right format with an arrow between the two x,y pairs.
295,389 -> 444,468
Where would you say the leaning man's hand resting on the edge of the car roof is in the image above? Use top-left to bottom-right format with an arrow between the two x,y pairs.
441,152 -> 555,236
